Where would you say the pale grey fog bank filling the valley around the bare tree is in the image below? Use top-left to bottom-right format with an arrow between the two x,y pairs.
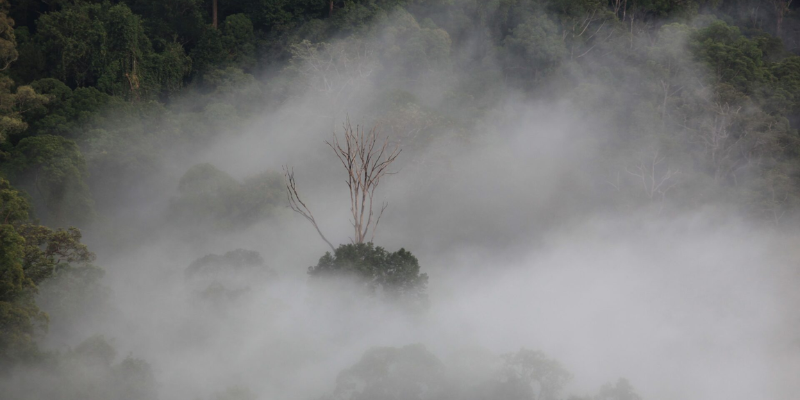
0,5 -> 800,400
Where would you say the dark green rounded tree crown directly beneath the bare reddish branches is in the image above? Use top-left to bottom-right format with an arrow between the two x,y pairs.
308,243 -> 428,307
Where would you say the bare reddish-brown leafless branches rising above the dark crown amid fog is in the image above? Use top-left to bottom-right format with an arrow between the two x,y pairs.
284,118 -> 401,250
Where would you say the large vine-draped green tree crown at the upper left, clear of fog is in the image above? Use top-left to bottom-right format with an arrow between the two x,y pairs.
37,2 -> 189,99
